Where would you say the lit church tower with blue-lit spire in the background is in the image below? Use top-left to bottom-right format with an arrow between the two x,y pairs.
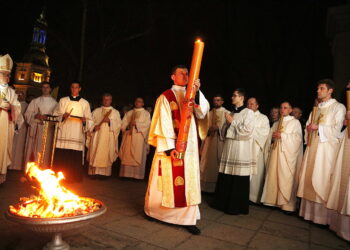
14,10 -> 51,96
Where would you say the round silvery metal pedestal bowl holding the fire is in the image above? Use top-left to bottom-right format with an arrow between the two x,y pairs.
5,199 -> 107,250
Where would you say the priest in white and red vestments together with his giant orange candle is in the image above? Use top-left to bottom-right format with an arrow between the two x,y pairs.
145,41 -> 209,234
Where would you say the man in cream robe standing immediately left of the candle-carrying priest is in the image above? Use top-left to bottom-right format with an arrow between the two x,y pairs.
119,97 -> 151,180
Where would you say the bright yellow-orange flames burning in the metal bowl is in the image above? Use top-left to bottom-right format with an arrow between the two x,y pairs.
10,162 -> 101,218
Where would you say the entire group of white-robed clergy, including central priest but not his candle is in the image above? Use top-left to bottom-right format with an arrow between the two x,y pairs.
0,55 -> 350,241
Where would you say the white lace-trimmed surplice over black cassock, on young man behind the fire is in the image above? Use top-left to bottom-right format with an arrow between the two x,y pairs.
54,96 -> 94,154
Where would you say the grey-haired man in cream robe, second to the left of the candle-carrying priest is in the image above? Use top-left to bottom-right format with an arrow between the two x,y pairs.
87,94 -> 121,176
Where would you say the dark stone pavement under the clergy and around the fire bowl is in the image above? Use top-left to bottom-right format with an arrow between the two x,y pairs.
0,171 -> 350,250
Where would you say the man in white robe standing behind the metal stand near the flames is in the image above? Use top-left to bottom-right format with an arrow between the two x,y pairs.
24,83 -> 57,167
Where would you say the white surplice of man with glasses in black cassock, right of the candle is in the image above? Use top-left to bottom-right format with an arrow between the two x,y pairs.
219,108 -> 257,176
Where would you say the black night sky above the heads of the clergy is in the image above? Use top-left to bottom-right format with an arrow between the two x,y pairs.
0,0 -> 347,113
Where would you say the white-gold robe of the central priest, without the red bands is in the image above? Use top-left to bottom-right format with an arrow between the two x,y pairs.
145,85 -> 209,225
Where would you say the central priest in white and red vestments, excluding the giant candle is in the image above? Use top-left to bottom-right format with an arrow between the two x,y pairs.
145,65 -> 209,234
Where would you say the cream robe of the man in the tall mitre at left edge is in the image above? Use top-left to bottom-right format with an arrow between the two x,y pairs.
0,84 -> 21,184
